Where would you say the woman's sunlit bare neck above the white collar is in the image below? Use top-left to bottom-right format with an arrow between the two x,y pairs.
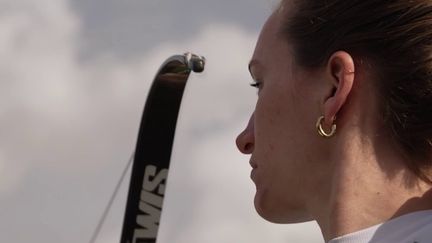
311,132 -> 432,242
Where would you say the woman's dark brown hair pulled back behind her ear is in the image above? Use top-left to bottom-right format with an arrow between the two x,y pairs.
282,0 -> 432,183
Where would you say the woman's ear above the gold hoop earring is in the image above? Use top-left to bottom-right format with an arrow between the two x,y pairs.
324,51 -> 355,125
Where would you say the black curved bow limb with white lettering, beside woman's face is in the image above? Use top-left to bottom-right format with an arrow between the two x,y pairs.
120,53 -> 205,243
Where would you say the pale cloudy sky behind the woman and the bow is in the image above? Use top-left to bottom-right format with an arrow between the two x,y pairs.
0,0 -> 323,243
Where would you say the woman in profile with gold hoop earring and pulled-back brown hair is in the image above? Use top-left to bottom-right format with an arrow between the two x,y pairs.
236,0 -> 432,243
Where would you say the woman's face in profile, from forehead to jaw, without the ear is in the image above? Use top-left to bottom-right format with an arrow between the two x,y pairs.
237,8 -> 325,223
